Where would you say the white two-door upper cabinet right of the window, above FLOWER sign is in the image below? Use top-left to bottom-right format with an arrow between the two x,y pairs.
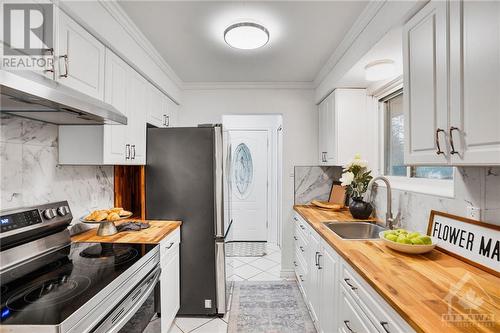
403,1 -> 500,166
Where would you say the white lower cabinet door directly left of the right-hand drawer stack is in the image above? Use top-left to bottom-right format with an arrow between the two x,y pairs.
318,245 -> 340,333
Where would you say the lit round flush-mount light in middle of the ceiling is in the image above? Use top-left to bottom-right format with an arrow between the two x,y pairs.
224,22 -> 269,50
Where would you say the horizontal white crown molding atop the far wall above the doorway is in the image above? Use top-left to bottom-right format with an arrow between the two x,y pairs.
182,82 -> 314,90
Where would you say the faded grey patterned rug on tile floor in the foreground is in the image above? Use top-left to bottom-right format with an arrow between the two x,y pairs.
228,280 -> 316,333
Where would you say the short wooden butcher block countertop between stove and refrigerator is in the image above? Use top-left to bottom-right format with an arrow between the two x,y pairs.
71,219 -> 181,244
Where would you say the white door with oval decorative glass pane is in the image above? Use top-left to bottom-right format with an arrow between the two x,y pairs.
229,131 -> 269,241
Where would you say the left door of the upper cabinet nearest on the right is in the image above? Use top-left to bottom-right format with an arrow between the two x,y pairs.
403,1 -> 449,165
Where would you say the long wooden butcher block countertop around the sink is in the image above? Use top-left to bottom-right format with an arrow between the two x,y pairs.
294,206 -> 500,333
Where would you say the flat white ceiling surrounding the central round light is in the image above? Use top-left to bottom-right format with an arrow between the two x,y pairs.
120,1 -> 367,82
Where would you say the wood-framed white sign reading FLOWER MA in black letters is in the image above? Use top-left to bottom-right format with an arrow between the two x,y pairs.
427,211 -> 500,276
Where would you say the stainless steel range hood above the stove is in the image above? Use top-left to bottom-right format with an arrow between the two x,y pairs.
0,70 -> 127,125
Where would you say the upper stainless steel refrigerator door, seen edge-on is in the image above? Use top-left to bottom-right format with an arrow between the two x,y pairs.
214,126 -> 224,238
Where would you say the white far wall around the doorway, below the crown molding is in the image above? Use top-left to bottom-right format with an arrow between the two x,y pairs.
179,89 -> 318,271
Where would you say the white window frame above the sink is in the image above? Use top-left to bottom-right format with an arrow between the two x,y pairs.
373,76 -> 456,198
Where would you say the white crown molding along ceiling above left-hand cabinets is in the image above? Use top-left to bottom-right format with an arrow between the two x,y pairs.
98,0 -> 183,89
